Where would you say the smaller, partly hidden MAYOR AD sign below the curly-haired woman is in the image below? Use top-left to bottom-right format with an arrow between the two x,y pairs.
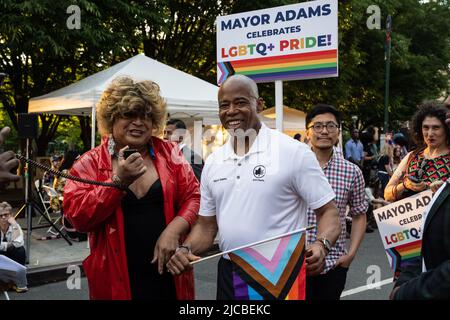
373,190 -> 432,272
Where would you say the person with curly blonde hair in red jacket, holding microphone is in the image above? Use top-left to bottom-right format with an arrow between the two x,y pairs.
63,77 -> 200,300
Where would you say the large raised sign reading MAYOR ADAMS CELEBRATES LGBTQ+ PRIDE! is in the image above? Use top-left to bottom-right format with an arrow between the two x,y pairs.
216,0 -> 338,85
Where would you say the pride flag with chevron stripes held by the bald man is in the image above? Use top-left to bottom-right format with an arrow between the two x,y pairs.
229,232 -> 306,300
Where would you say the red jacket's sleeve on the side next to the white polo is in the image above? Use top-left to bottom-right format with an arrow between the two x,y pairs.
176,146 -> 200,227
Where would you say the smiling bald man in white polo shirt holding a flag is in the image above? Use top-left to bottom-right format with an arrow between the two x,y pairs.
167,75 -> 341,300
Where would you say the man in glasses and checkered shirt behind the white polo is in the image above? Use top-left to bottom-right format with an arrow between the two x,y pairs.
306,104 -> 368,300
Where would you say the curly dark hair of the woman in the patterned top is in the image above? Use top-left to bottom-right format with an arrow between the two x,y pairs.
411,101 -> 450,147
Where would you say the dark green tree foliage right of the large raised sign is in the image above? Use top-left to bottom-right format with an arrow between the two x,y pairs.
278,0 -> 450,128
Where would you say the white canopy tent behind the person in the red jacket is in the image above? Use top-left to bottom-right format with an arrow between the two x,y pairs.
28,53 -> 219,146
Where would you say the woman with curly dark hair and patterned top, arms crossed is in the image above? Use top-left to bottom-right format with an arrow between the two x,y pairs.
384,102 -> 450,201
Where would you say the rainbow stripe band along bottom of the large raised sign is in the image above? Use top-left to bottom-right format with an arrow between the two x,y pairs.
218,50 -> 338,84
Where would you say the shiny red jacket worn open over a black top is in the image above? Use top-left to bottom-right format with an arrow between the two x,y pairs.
63,138 -> 200,300
